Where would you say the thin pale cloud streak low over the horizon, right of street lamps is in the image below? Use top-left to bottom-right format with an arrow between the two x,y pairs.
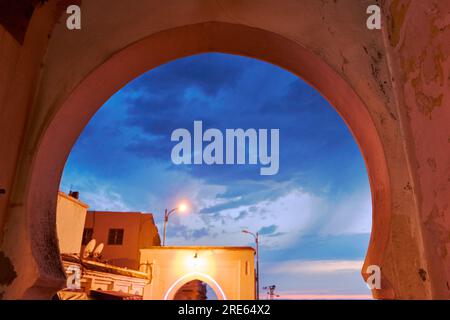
267,260 -> 364,274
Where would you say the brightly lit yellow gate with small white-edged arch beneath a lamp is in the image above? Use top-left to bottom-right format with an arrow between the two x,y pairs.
140,246 -> 256,300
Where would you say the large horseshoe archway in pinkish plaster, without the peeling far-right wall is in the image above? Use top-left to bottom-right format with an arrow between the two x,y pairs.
0,0 -> 446,298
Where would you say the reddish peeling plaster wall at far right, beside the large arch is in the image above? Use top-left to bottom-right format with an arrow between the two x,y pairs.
385,0 -> 450,299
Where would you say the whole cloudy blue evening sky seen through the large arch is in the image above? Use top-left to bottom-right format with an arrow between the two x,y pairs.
61,53 -> 371,298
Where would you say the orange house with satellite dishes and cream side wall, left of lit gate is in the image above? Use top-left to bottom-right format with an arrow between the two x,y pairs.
54,192 -> 159,300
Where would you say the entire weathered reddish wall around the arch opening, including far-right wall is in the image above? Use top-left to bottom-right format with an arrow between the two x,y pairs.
0,0 -> 450,299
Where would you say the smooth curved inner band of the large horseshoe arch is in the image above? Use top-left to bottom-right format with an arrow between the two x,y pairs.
25,22 -> 391,298
